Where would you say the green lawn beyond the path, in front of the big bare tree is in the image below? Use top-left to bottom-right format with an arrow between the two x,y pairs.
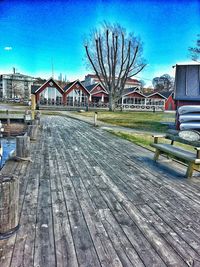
74,111 -> 175,132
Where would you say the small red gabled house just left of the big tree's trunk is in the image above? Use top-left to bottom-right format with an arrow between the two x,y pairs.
86,83 -> 109,106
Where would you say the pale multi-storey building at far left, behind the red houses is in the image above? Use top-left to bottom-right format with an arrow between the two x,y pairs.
0,71 -> 35,100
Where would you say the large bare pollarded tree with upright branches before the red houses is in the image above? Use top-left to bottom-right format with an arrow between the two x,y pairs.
85,23 -> 145,111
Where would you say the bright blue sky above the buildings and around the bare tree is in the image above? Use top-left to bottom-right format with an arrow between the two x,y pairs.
0,0 -> 200,84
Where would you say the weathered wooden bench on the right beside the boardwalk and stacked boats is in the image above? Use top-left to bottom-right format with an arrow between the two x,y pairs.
151,134 -> 200,178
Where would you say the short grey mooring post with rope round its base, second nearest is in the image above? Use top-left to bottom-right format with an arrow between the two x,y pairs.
16,135 -> 30,160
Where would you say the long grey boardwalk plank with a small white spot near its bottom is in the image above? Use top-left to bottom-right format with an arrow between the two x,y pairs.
34,136 -> 56,267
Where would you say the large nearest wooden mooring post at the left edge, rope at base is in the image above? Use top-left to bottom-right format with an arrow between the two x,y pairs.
0,174 -> 19,239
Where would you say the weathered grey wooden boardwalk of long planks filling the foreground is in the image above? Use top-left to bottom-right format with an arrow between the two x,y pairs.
0,116 -> 200,267
